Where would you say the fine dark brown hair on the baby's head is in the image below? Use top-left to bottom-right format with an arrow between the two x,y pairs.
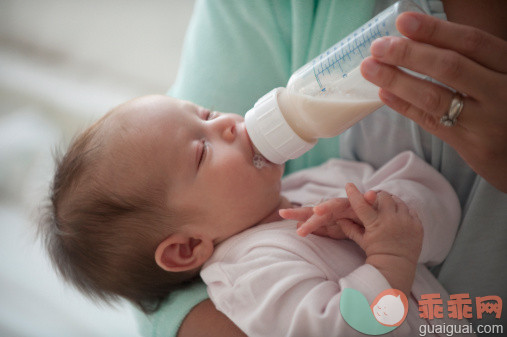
39,109 -> 196,313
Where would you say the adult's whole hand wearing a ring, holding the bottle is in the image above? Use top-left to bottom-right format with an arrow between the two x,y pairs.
361,13 -> 507,192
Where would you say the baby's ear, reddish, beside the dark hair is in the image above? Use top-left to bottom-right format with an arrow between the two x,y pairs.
155,233 -> 213,272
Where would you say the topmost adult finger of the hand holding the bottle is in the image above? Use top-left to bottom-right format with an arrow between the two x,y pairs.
396,12 -> 507,73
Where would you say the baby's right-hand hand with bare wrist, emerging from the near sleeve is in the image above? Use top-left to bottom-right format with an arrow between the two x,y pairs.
342,184 -> 423,294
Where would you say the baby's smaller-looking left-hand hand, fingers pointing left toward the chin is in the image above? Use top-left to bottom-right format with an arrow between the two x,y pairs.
279,198 -> 358,239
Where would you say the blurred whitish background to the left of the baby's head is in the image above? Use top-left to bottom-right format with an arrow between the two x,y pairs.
0,0 -> 194,337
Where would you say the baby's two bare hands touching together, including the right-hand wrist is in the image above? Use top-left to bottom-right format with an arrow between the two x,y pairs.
280,184 -> 423,296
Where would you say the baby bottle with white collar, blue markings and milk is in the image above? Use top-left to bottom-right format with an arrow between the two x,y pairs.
245,0 -> 424,164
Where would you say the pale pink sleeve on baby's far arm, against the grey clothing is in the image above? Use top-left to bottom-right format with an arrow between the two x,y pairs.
363,151 -> 461,265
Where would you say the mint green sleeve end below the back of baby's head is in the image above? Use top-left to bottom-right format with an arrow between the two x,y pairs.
135,281 -> 208,337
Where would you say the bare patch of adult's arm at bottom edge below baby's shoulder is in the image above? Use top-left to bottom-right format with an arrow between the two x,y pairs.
178,299 -> 246,337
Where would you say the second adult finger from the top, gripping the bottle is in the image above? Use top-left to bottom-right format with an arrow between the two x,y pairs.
371,37 -> 499,99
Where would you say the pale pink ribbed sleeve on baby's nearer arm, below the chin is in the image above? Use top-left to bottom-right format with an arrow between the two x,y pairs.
201,242 -> 410,337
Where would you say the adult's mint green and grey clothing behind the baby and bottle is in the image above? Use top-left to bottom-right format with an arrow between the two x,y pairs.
138,0 -> 507,337
